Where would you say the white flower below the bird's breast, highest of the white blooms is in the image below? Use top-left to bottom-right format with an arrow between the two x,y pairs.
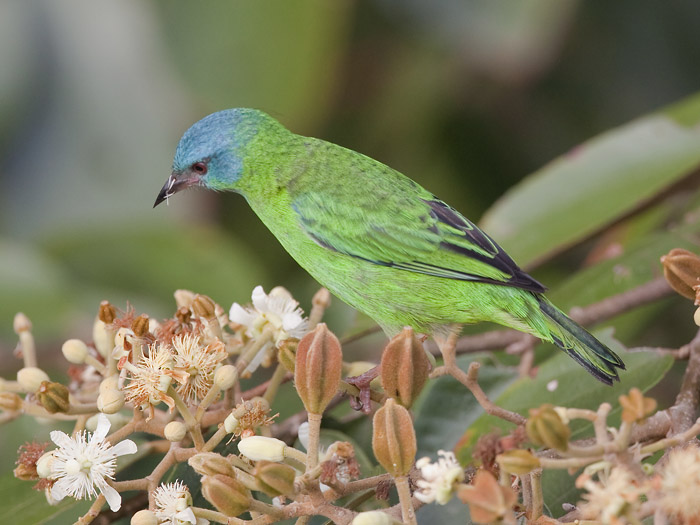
229,286 -> 308,372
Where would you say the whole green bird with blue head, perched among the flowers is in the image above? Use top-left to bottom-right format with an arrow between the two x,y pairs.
154,108 -> 625,384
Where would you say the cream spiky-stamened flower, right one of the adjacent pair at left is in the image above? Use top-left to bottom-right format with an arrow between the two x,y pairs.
172,334 -> 228,404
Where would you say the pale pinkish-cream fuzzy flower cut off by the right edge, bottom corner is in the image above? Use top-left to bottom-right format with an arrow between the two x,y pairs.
658,446 -> 700,524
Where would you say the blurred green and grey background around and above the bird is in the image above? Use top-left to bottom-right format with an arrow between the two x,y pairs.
0,0 -> 700,370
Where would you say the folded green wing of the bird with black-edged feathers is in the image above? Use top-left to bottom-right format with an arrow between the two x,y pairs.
293,179 -> 545,292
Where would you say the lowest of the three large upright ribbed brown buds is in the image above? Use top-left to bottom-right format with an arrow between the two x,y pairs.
372,398 -> 416,478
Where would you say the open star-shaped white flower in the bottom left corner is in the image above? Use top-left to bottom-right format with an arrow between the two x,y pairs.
50,414 -> 136,511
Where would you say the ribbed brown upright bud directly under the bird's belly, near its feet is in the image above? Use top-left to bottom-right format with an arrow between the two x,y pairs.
381,326 -> 430,408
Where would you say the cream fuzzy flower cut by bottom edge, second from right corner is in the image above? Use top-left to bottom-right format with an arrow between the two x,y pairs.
576,467 -> 644,525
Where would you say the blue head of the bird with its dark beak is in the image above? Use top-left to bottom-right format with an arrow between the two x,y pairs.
154,108 -> 272,207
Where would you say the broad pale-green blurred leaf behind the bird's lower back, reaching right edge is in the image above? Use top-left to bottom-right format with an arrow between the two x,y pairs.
481,91 -> 700,266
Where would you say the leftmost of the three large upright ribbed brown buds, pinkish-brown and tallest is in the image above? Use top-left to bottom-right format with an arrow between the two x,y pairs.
294,323 -> 343,414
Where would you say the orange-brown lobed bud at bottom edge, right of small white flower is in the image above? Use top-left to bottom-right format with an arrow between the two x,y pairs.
457,469 -> 516,523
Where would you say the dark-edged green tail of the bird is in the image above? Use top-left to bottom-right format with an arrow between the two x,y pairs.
537,295 -> 625,385
